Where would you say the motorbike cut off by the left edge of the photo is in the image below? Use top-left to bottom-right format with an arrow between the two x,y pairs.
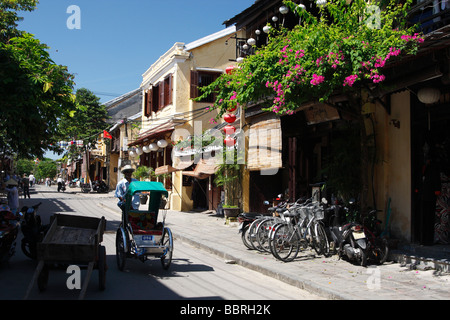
0,210 -> 20,263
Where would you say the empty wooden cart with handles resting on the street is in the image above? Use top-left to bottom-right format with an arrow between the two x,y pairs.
25,214 -> 107,299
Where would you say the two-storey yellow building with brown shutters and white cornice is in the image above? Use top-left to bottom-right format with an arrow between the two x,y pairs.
128,26 -> 244,211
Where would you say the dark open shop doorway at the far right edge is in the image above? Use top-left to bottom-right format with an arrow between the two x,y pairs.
411,91 -> 450,245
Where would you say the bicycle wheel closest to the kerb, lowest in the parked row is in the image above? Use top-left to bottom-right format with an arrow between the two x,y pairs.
272,223 -> 299,262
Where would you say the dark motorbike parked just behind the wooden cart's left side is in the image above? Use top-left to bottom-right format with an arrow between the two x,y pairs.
20,202 -> 49,260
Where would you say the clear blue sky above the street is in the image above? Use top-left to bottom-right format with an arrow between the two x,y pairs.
19,0 -> 255,102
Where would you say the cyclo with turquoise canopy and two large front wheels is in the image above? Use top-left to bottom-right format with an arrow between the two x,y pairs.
116,181 -> 173,271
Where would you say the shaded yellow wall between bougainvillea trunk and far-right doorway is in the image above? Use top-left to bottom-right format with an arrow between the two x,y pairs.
375,91 -> 411,241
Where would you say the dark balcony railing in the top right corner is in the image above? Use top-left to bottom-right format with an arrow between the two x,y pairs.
408,0 -> 450,34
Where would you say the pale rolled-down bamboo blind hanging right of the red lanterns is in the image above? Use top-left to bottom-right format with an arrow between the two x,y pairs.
247,114 -> 282,171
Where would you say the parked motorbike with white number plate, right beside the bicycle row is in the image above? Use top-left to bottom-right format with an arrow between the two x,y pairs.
326,204 -> 368,266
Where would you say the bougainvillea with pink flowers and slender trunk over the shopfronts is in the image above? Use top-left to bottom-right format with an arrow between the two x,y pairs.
199,0 -> 423,207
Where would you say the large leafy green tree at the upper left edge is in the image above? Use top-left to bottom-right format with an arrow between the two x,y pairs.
0,0 -> 75,158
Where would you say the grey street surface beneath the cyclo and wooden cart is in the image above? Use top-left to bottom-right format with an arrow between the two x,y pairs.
0,185 -> 321,300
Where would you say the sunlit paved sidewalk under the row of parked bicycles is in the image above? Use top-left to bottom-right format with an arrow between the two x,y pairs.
98,192 -> 450,300
